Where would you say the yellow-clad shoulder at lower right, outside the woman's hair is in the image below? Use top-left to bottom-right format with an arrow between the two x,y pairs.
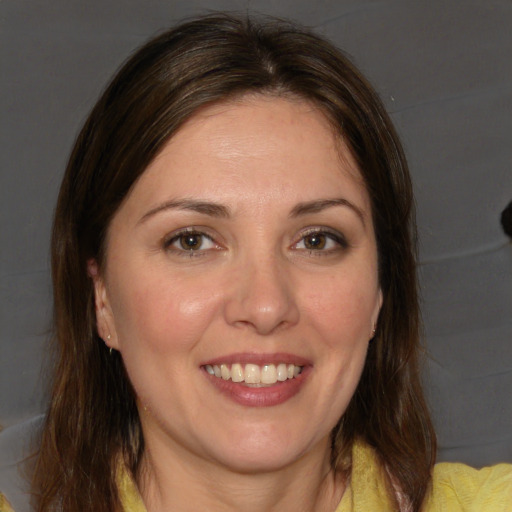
427,463 -> 512,512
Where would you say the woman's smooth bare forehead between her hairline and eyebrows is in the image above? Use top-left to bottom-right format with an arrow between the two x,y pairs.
122,95 -> 369,216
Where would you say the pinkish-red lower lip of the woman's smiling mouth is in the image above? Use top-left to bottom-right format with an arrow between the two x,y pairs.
204,367 -> 310,407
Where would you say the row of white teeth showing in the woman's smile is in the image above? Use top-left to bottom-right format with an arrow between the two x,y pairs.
204,363 -> 304,387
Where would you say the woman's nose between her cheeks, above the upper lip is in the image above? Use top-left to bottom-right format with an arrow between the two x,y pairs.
225,256 -> 300,335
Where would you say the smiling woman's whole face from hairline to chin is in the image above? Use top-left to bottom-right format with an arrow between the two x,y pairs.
91,96 -> 381,471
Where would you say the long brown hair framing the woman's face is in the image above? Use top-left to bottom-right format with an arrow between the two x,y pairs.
33,15 -> 435,512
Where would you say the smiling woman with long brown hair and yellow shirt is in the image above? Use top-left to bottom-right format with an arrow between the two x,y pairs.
1,15 -> 512,512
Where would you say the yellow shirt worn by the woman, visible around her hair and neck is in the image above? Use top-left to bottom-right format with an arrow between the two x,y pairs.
0,444 -> 512,512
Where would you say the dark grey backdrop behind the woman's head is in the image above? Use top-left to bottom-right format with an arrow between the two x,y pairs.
0,0 -> 512,465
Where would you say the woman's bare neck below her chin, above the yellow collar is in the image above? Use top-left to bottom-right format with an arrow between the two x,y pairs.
138,432 -> 345,512
